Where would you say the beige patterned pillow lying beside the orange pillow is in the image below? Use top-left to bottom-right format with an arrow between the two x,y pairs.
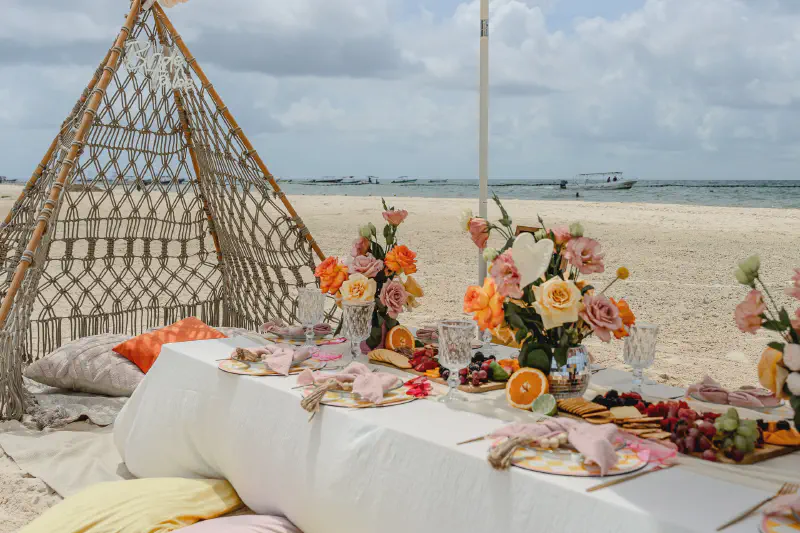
25,333 -> 144,396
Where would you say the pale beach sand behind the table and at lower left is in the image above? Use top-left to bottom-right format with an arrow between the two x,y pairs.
0,185 -> 800,533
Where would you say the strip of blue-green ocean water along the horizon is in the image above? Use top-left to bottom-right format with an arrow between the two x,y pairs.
280,178 -> 800,209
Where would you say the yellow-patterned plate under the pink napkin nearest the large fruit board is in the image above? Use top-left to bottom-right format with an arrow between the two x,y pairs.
514,442 -> 647,477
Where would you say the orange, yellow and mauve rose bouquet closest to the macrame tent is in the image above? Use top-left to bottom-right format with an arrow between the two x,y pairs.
314,200 -> 424,349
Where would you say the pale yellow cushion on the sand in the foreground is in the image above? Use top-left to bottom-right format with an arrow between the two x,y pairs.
20,478 -> 242,533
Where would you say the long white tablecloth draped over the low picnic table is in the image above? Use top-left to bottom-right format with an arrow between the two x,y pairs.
115,338 -> 798,533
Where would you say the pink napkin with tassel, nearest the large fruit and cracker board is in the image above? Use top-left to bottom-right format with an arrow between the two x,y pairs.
489,418 -> 618,475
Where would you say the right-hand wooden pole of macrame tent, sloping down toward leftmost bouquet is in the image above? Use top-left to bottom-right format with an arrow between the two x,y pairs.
153,2 -> 325,260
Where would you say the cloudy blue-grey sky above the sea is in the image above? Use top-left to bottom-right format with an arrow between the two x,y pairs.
0,0 -> 800,179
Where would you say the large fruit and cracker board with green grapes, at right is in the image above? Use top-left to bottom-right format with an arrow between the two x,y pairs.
558,390 -> 800,464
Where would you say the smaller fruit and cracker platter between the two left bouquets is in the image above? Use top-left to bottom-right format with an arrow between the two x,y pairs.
369,344 -> 519,393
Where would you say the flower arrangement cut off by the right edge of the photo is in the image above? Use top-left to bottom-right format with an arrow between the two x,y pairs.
734,255 -> 800,427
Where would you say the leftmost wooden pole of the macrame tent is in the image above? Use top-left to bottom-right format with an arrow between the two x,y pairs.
0,0 -> 142,326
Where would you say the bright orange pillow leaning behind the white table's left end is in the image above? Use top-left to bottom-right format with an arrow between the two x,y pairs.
114,317 -> 227,374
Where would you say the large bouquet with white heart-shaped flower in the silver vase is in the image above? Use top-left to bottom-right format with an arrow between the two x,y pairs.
461,195 -> 636,375
